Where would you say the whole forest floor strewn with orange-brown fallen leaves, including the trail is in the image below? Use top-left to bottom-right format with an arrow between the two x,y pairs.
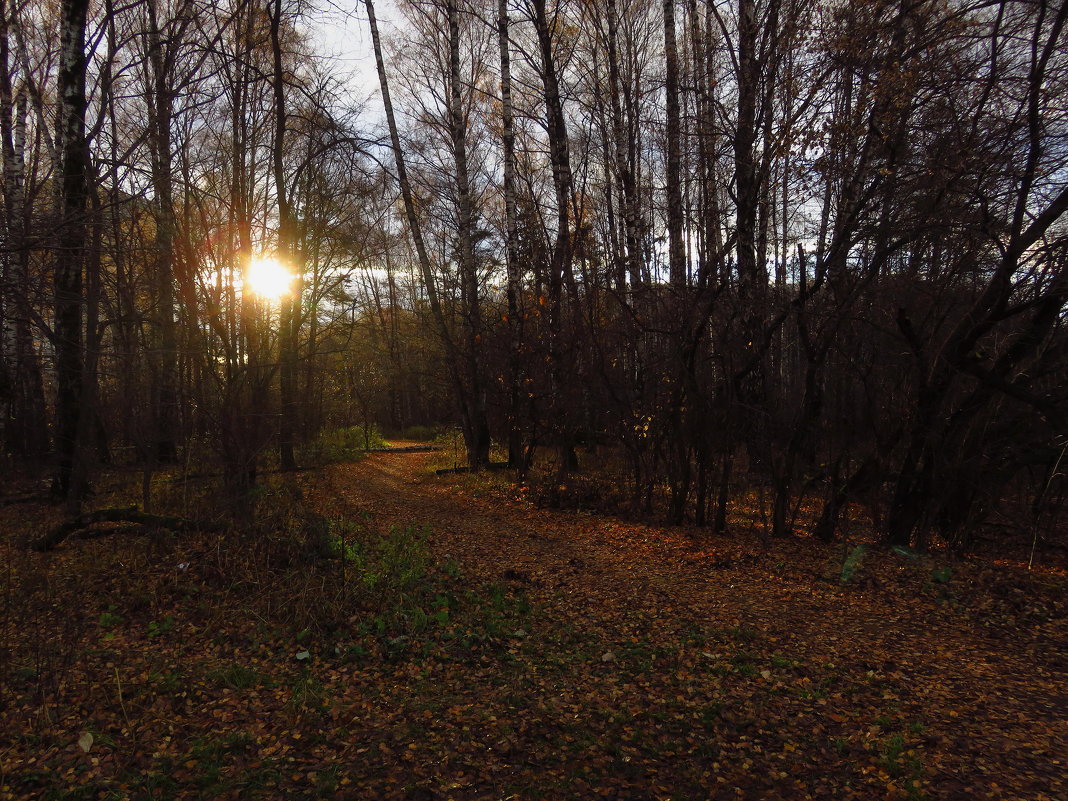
0,452 -> 1068,801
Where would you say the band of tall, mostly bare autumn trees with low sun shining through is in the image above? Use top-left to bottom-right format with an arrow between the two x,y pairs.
0,0 -> 1068,548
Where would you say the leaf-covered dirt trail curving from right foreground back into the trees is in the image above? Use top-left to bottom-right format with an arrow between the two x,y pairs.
307,453 -> 1068,799
